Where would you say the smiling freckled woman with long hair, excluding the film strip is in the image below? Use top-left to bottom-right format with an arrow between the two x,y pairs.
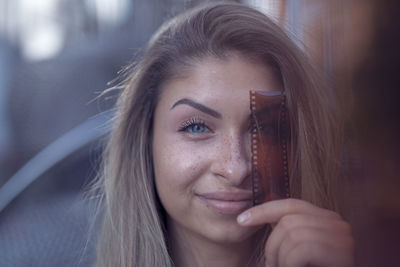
97,3 -> 353,267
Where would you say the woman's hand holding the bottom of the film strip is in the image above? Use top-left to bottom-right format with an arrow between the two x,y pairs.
238,199 -> 354,267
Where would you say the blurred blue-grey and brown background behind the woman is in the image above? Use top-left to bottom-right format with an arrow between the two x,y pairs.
0,0 -> 400,266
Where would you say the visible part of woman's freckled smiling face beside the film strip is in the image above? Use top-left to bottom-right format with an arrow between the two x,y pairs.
153,56 -> 281,246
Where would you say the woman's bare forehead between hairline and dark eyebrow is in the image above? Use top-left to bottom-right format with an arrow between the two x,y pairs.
160,55 -> 282,107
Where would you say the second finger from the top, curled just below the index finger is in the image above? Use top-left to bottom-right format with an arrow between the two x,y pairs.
265,217 -> 351,262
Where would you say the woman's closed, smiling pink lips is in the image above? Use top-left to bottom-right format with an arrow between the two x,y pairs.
197,191 -> 253,215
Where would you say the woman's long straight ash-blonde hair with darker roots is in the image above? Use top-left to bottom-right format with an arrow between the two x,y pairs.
93,2 -> 338,267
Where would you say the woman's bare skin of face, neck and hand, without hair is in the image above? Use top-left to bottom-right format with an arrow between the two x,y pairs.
153,55 -> 351,267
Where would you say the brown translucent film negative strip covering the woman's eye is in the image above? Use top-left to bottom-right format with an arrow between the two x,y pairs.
250,91 -> 290,205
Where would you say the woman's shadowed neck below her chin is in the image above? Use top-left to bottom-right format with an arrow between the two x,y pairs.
168,220 -> 254,267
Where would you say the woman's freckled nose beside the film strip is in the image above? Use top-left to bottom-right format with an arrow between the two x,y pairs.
211,133 -> 251,186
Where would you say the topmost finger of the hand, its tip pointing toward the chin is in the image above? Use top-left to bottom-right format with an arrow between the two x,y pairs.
237,198 -> 340,226
